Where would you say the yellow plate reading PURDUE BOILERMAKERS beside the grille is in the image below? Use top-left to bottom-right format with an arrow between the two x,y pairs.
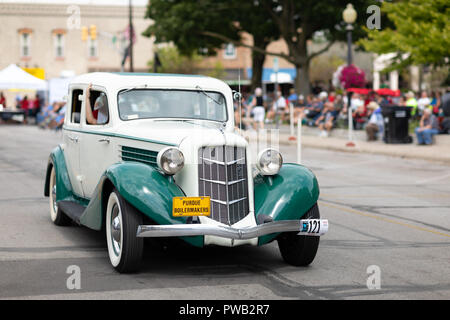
172,197 -> 211,217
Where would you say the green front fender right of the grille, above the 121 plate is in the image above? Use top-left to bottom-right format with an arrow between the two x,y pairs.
254,164 -> 319,245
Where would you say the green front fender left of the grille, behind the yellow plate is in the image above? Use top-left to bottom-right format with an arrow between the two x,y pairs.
81,162 -> 203,247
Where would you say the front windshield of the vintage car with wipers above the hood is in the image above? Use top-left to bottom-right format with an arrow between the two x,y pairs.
118,88 -> 227,122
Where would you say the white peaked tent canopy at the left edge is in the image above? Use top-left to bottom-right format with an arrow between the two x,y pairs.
0,64 -> 47,90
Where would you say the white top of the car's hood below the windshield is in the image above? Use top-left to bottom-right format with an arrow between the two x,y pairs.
116,120 -> 244,146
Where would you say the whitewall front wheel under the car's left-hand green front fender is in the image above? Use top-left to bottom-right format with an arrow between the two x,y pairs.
106,189 -> 144,273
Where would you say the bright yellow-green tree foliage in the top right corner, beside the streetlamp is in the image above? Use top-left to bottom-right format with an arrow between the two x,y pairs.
360,0 -> 450,70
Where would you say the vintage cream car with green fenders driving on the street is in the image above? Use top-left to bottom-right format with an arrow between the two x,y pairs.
45,73 -> 328,272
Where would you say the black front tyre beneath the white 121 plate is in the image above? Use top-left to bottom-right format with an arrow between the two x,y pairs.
278,203 -> 320,266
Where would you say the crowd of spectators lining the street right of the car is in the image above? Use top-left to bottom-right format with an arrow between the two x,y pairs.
235,88 -> 442,144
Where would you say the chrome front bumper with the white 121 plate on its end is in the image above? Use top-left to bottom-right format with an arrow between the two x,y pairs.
136,219 -> 328,240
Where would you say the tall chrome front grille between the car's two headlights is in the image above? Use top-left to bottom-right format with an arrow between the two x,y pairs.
198,146 -> 249,225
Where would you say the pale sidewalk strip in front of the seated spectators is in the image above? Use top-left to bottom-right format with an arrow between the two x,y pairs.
243,125 -> 450,164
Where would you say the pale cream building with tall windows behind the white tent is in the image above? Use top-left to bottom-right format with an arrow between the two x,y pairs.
0,0 -> 153,79
